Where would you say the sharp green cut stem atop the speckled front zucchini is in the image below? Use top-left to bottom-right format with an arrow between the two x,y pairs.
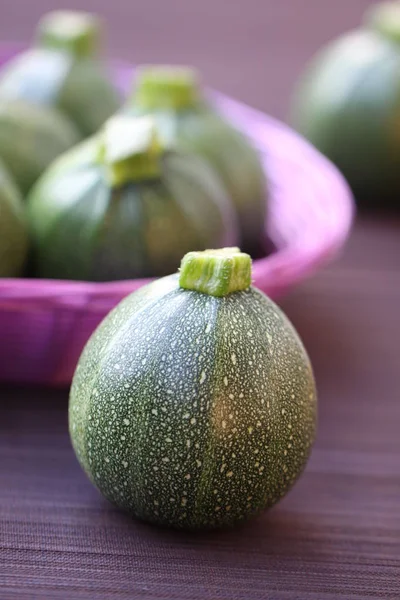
179,248 -> 251,298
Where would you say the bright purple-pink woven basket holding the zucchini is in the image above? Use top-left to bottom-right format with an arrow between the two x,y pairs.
0,46 -> 353,386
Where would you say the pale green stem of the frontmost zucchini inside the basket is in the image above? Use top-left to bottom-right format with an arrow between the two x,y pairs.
99,115 -> 162,187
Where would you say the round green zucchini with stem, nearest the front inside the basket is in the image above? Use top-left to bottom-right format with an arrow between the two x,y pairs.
29,115 -> 237,281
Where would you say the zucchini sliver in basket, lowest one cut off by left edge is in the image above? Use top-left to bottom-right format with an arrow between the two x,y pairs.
0,163 -> 28,277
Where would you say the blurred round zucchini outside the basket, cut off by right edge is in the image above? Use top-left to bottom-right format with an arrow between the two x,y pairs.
292,2 -> 400,206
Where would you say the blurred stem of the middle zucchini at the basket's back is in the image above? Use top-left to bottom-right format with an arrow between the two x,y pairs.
134,66 -> 201,110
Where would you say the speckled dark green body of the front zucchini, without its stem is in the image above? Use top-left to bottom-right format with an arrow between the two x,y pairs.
69,275 -> 316,529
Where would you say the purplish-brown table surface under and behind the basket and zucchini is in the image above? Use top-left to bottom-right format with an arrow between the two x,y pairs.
0,0 -> 400,600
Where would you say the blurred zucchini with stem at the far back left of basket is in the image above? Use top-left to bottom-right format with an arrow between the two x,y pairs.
0,11 -> 120,136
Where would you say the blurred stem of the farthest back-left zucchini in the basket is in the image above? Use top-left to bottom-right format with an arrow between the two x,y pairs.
36,11 -> 103,58
